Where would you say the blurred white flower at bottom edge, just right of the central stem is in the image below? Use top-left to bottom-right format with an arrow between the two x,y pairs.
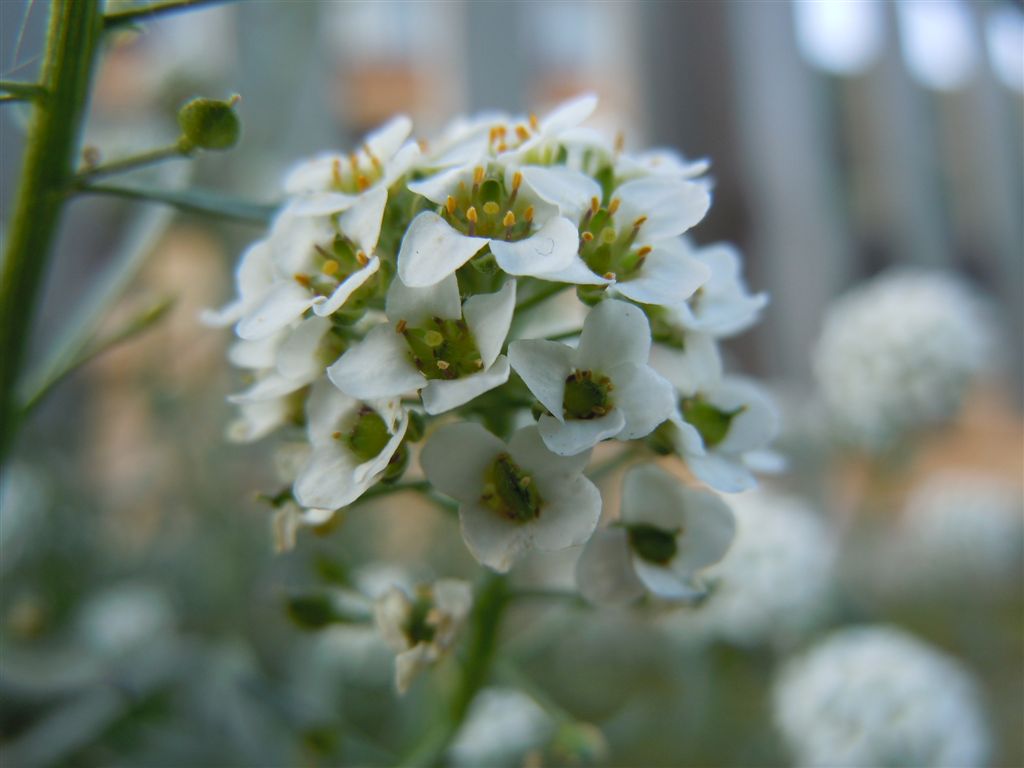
449,688 -> 554,768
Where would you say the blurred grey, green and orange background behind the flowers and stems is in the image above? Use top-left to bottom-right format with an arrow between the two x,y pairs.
0,0 -> 1024,768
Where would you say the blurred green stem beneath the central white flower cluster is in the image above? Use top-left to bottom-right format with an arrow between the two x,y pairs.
400,571 -> 509,768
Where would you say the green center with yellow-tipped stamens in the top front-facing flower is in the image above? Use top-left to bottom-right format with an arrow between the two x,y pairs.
440,166 -> 534,241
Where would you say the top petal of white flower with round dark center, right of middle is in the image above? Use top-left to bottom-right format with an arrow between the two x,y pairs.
575,299 -> 650,373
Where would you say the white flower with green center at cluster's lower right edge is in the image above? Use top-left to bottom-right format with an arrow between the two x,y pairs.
655,372 -> 782,493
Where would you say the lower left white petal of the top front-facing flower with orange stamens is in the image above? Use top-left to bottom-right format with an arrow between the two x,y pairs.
398,211 -> 488,287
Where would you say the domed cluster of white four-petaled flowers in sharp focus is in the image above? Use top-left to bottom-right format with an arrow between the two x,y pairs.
208,95 -> 777,692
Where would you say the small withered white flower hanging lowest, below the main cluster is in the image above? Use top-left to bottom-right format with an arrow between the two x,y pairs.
374,579 -> 473,693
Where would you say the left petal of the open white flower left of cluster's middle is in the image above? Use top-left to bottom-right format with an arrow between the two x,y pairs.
327,325 -> 426,400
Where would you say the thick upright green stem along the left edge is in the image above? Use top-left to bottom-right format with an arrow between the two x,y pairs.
0,0 -> 102,461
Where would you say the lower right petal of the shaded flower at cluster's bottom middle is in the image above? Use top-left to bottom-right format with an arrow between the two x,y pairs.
531,475 -> 601,552
